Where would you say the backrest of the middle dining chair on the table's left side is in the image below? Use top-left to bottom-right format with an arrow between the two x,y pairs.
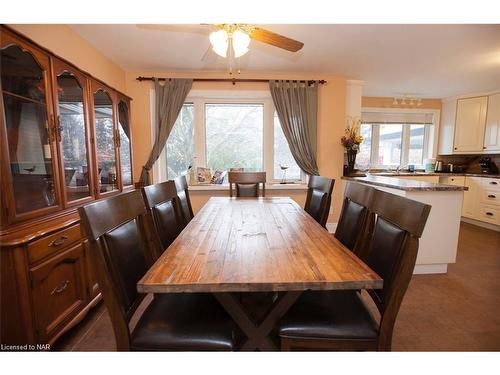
142,181 -> 183,257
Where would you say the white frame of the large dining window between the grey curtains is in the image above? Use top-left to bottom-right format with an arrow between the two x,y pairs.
150,89 -> 307,184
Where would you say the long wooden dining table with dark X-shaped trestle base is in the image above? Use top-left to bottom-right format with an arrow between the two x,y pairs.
137,197 -> 383,350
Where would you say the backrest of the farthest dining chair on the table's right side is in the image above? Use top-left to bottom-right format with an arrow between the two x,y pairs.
304,176 -> 335,227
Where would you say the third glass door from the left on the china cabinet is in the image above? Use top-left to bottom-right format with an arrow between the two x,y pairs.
93,89 -> 118,194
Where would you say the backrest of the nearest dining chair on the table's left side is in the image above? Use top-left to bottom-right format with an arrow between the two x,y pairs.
78,190 -> 157,347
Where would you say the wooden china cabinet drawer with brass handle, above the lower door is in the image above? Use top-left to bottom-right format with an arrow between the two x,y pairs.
28,224 -> 82,263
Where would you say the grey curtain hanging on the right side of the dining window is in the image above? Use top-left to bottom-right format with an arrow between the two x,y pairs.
269,81 -> 319,175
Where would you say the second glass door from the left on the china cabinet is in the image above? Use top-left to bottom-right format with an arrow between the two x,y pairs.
55,66 -> 92,203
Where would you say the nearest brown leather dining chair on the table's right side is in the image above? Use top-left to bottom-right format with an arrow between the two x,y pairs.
279,190 -> 431,351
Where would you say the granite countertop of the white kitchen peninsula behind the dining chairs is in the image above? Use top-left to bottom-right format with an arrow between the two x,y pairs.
342,175 -> 468,191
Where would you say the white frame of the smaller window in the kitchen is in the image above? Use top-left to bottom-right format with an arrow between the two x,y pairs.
357,107 -> 440,169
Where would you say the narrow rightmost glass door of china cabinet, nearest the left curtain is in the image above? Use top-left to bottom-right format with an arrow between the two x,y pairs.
118,99 -> 133,187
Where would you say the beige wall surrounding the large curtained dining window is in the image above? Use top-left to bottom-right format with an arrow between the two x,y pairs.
126,72 -> 346,222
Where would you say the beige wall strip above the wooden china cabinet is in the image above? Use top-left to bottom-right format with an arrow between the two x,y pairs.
8,24 -> 125,93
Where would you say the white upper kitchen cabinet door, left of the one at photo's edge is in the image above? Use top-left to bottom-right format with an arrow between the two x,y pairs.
453,96 -> 488,153
